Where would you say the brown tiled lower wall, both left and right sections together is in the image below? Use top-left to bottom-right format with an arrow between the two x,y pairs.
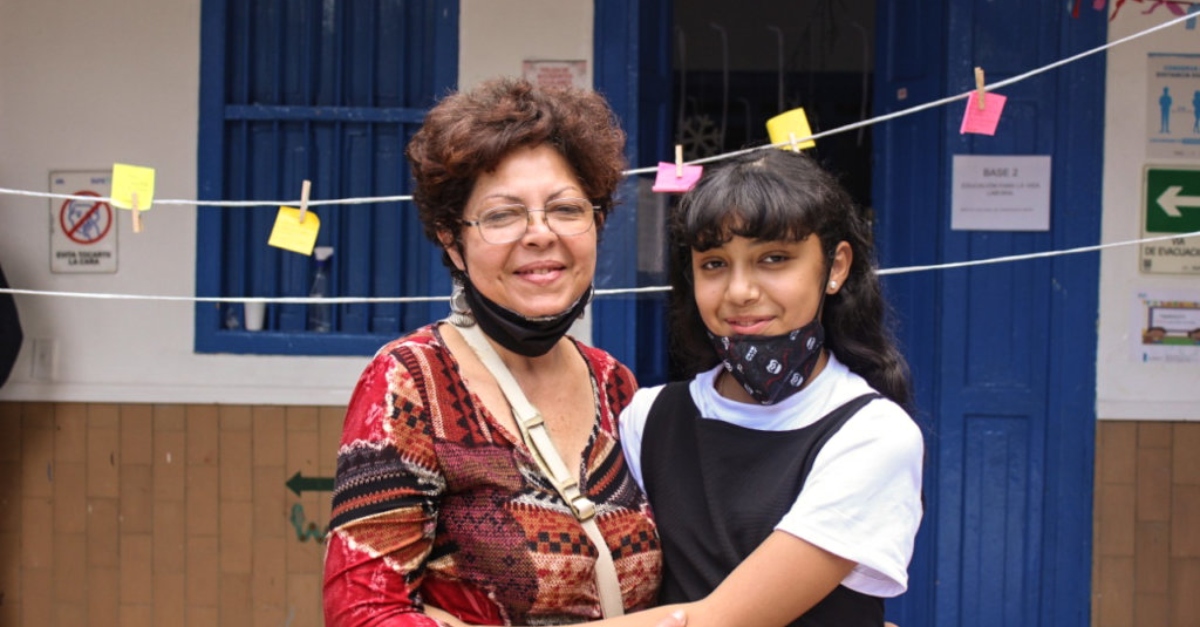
0,402 -> 1200,627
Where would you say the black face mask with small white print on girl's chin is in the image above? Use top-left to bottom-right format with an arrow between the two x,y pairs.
708,318 -> 824,405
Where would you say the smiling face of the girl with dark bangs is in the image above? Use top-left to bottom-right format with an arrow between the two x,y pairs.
691,235 -> 852,335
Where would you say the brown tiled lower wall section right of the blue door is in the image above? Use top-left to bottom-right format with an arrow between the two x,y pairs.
1092,420 -> 1200,627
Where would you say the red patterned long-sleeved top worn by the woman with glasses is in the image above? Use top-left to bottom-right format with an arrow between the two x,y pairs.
324,326 -> 661,627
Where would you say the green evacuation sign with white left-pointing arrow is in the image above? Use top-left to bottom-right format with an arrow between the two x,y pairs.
1140,166 -> 1200,275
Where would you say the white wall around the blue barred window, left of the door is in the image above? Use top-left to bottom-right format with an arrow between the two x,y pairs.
0,0 -> 592,405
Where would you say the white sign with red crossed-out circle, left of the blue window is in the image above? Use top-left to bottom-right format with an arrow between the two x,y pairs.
50,171 -> 118,273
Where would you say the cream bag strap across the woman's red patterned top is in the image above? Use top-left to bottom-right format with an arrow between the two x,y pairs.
451,322 -> 625,619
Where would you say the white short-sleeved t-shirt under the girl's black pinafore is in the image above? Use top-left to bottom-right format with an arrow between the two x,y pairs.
620,354 -> 924,597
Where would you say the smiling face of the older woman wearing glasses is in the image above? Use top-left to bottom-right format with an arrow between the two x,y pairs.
442,145 -> 596,317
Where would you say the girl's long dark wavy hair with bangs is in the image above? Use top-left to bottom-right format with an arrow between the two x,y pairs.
670,149 -> 911,408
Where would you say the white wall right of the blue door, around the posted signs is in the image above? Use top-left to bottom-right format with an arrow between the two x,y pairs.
1099,9 -> 1200,420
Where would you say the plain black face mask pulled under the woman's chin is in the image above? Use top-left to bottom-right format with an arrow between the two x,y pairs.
451,279 -> 592,357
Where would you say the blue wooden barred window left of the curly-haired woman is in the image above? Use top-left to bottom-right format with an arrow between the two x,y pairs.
196,0 -> 458,354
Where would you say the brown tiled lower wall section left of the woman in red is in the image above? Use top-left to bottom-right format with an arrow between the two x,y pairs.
0,402 -> 343,627
